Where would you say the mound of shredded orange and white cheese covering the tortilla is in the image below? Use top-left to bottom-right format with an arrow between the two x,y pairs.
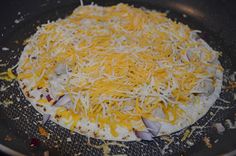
17,4 -> 222,136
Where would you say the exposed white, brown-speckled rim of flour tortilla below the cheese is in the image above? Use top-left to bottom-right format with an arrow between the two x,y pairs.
17,3 -> 223,141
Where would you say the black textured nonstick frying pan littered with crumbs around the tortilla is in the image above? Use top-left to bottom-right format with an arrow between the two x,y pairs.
0,0 -> 236,155
